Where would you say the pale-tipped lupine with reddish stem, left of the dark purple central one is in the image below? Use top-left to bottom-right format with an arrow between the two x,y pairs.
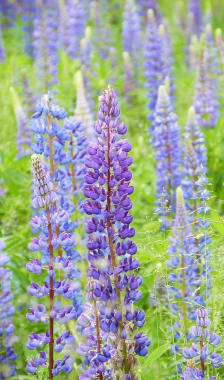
27,155 -> 79,379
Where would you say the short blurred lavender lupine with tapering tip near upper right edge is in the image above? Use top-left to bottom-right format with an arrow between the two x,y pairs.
194,49 -> 219,128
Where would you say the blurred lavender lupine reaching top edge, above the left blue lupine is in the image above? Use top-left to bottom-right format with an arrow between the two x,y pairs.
33,0 -> 58,91
